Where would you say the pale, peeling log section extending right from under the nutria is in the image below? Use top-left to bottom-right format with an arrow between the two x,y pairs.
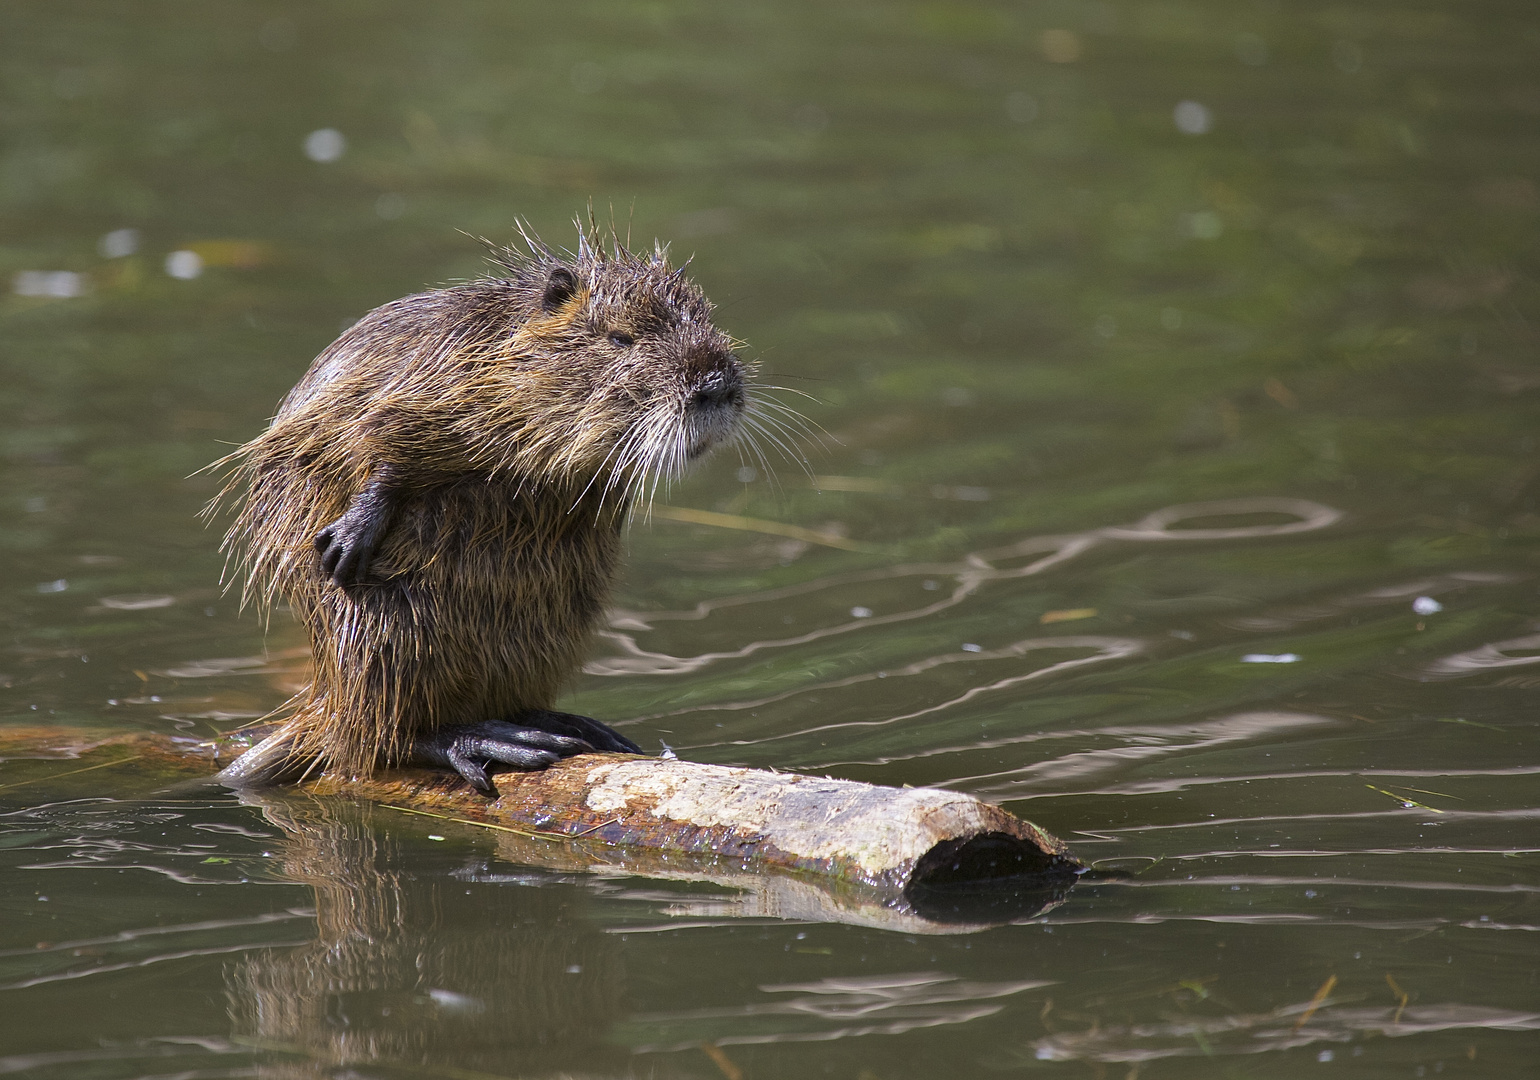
306,753 -> 1078,889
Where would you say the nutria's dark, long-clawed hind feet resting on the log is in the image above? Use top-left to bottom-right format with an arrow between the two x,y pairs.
411,710 -> 642,797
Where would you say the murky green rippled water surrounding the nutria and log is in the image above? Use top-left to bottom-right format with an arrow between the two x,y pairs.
0,0 -> 1540,1080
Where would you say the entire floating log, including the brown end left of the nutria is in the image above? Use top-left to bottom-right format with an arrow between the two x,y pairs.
0,729 -> 1084,923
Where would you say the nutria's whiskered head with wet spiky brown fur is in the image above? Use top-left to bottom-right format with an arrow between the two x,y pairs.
449,224 -> 776,496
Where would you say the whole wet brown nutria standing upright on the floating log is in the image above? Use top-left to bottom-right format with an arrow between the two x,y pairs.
209,222 -> 773,793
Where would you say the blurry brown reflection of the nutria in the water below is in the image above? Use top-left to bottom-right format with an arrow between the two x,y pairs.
225,797 -> 625,1077
